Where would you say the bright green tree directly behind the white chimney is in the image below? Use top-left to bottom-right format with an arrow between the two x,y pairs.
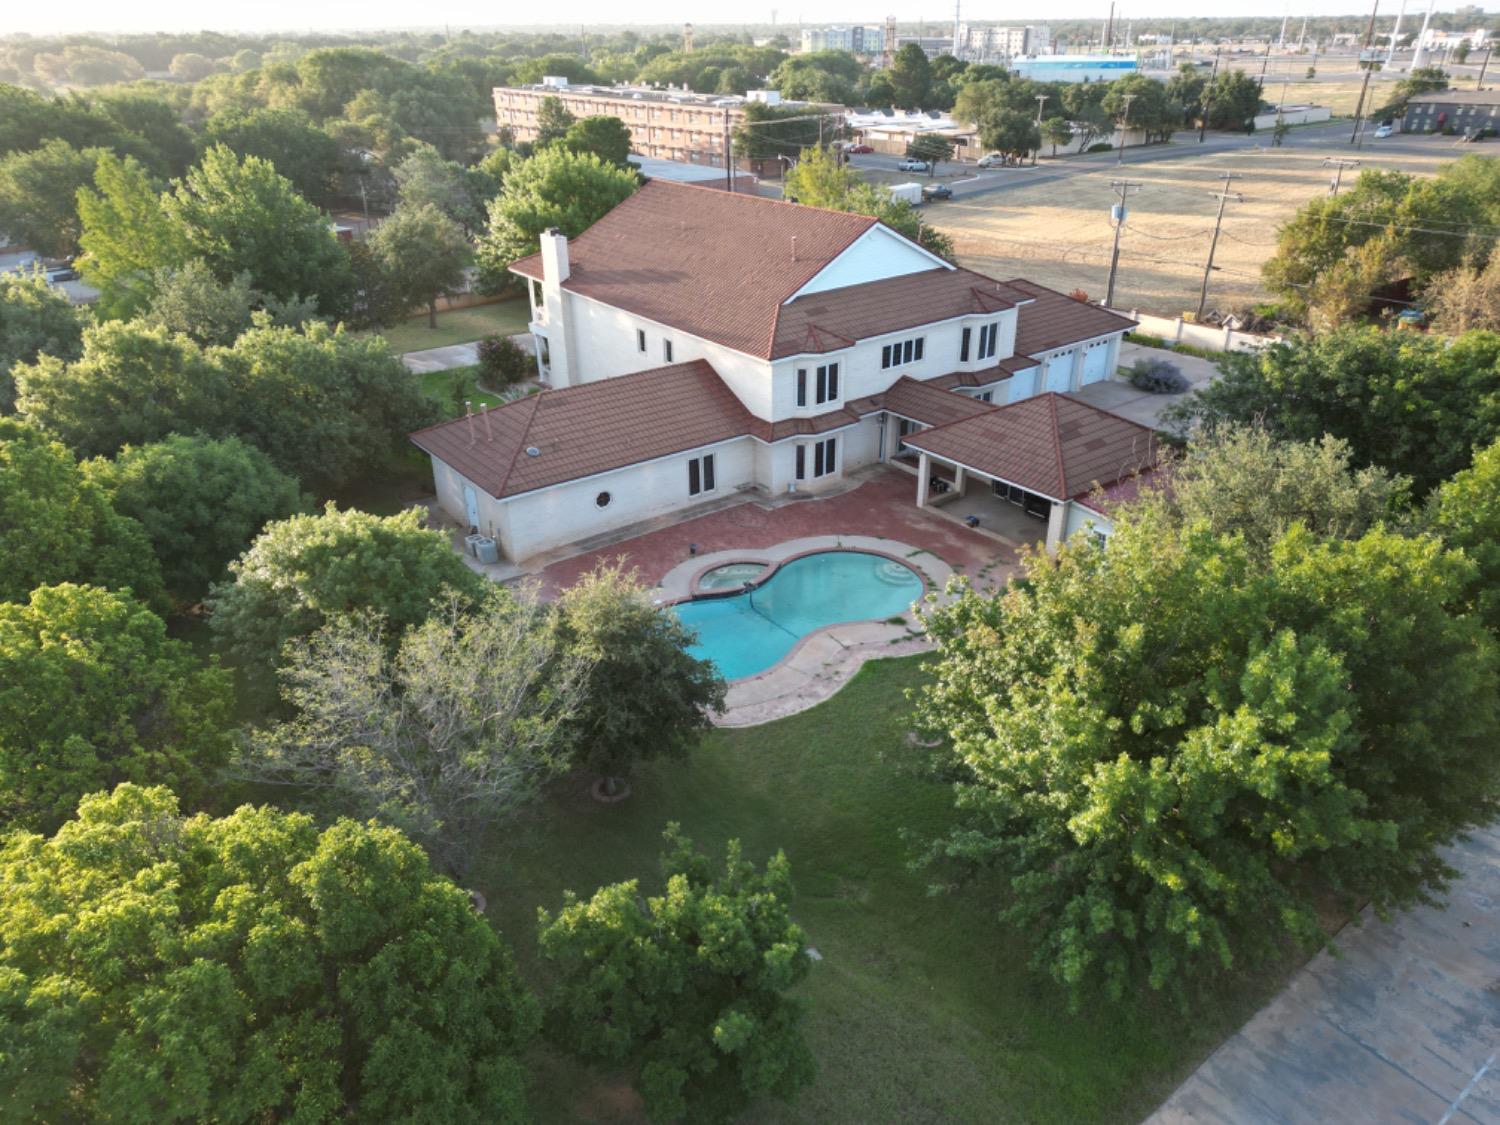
477,149 -> 636,290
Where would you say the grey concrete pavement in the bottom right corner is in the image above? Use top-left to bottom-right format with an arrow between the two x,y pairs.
1146,827 -> 1500,1125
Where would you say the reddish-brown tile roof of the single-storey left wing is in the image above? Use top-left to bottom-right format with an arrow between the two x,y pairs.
411,360 -> 770,498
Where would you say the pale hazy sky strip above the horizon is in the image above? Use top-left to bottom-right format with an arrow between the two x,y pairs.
14,0 -> 1496,33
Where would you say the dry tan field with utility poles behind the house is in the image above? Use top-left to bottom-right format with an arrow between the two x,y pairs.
927,146 -> 1461,315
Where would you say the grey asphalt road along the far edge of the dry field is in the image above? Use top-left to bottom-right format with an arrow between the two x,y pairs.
849,120 -> 1482,207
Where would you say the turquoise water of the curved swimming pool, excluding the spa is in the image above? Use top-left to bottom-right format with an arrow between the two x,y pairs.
672,551 -> 924,680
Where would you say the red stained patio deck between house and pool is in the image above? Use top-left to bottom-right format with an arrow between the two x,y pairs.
539,468 -> 1016,596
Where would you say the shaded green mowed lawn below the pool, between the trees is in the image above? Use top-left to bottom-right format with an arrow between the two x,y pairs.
479,657 -> 1280,1124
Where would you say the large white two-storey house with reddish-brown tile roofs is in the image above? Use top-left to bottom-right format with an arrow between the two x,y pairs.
413,180 -> 1155,561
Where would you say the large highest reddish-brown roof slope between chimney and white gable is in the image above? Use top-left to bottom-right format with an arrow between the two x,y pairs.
510,180 -> 876,359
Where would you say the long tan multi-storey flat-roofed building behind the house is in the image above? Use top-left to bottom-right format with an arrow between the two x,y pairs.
494,78 -> 839,176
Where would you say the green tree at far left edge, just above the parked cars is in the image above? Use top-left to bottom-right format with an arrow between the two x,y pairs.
0,140 -> 104,258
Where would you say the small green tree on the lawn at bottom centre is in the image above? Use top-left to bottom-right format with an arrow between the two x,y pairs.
537,824 -> 815,1122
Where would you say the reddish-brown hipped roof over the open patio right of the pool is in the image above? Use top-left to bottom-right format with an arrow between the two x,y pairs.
906,393 -> 1157,500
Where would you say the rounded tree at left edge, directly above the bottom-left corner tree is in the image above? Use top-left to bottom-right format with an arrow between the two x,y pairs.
0,585 -> 234,831
